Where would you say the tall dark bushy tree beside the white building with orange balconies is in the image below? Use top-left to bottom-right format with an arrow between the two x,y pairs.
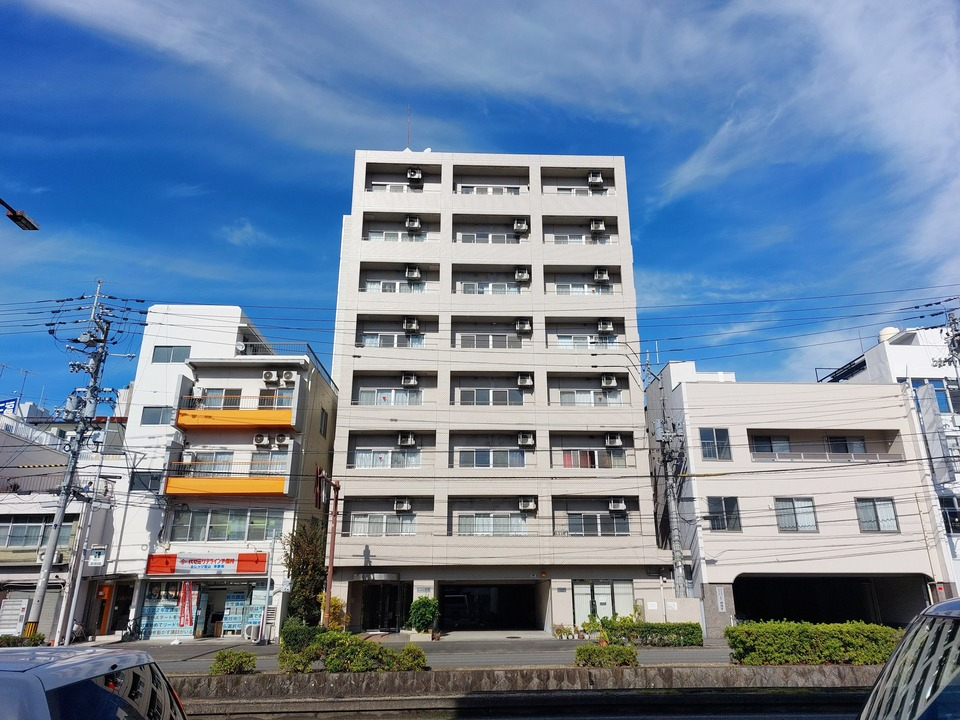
281,518 -> 327,625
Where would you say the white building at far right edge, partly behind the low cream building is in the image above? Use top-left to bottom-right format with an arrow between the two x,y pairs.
822,327 -> 960,584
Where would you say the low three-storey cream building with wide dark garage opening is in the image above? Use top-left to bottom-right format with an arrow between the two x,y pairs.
647,362 -> 950,637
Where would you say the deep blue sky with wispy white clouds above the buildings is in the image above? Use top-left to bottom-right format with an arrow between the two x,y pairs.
0,0 -> 960,405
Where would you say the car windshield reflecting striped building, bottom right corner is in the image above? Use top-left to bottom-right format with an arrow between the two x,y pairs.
860,615 -> 960,720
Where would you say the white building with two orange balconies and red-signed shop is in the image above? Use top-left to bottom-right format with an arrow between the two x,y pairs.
109,305 -> 336,639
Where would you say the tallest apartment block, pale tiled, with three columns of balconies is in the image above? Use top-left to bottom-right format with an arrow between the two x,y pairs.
333,151 -> 684,629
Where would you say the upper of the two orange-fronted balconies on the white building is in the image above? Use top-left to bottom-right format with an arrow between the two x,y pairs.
177,396 -> 295,430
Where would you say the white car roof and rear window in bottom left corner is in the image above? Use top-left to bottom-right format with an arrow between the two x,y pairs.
0,647 -> 187,720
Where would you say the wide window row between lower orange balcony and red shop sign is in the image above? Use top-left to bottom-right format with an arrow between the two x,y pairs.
170,508 -> 283,542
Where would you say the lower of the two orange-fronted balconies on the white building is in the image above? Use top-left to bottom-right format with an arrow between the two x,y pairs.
165,460 -> 290,495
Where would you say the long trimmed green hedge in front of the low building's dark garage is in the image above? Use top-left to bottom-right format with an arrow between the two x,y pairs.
723,621 -> 903,665
